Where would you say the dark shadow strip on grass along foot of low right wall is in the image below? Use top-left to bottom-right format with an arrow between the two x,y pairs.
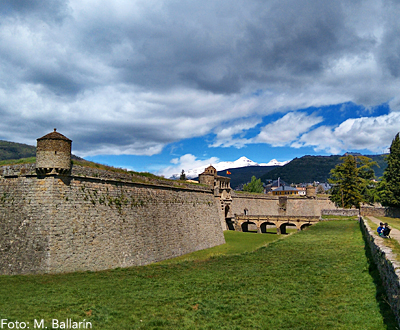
360,223 -> 399,330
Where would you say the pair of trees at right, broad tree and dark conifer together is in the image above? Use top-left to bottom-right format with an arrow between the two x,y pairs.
329,133 -> 400,208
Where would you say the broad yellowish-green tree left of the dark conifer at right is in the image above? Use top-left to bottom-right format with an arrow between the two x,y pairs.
328,155 -> 377,208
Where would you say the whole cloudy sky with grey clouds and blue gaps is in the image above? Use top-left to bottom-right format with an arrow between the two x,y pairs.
0,0 -> 400,176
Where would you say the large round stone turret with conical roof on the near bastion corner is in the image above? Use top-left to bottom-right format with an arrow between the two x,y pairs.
36,129 -> 72,174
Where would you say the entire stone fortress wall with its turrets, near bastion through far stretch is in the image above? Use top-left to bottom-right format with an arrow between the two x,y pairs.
0,130 -> 368,274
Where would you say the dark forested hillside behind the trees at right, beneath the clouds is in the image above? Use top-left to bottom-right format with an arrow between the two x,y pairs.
261,155 -> 387,183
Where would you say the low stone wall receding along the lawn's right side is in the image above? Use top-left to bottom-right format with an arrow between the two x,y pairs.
360,217 -> 400,326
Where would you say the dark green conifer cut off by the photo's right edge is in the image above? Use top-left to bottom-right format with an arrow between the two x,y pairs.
379,133 -> 400,207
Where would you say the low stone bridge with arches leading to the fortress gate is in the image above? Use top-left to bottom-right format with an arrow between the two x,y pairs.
231,215 -> 321,234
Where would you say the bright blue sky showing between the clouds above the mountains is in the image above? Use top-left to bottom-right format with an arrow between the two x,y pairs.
87,102 -> 390,173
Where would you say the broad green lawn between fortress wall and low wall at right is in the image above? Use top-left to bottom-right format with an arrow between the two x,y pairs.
0,221 -> 396,330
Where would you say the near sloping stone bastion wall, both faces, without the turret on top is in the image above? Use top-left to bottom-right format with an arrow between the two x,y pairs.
0,171 -> 225,274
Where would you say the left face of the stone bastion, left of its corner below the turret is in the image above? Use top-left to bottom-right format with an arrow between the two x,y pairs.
0,177 -> 52,274
